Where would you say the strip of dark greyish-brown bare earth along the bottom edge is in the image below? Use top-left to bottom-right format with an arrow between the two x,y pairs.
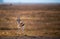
0,36 -> 60,39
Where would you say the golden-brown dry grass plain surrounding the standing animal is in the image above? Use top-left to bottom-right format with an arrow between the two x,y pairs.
0,4 -> 60,36
